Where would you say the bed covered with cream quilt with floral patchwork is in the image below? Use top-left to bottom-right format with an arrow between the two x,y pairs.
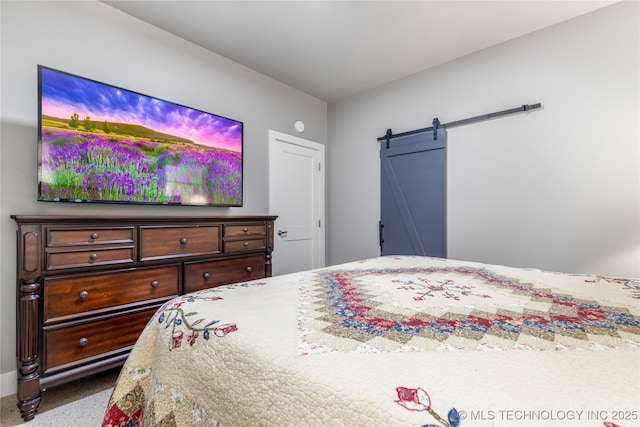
103,256 -> 640,427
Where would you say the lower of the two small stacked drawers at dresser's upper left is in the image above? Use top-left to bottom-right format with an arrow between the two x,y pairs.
46,246 -> 134,270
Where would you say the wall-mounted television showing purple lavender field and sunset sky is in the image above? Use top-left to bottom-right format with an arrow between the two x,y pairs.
38,65 -> 243,206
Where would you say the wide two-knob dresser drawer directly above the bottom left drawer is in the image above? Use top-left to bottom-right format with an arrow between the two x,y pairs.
43,264 -> 180,325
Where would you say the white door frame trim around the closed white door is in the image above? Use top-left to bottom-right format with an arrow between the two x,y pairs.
269,130 -> 327,274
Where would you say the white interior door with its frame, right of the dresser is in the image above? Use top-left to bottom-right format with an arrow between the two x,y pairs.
269,131 -> 325,276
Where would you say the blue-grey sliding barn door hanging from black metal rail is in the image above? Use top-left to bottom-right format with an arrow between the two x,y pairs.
380,129 -> 447,258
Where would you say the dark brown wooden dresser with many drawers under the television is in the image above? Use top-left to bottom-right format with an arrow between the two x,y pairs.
11,215 -> 276,420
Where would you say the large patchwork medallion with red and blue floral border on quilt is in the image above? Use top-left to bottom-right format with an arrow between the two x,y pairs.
299,264 -> 640,354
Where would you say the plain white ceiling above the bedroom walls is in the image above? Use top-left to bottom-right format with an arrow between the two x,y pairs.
102,0 -> 615,102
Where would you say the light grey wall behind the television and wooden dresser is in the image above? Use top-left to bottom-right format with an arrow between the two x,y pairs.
0,0 -> 327,395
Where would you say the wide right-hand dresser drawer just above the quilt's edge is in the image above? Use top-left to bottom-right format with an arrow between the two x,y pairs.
184,254 -> 265,292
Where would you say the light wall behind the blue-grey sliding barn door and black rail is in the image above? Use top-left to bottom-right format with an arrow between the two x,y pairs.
327,1 -> 640,277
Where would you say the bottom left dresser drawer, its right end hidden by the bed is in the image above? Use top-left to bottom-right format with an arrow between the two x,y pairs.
44,307 -> 158,373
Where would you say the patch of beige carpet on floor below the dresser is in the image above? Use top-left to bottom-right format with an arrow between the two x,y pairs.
0,368 -> 120,427
